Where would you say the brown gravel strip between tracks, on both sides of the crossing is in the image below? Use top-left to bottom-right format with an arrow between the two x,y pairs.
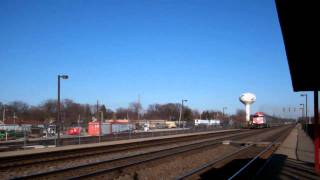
110,128 -> 292,180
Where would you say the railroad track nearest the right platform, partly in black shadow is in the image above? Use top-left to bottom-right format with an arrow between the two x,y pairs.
176,124 -> 292,180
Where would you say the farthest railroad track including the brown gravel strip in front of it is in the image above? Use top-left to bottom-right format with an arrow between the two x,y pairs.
0,130 -> 248,179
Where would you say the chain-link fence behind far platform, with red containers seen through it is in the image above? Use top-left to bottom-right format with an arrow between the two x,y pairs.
0,121 -> 240,151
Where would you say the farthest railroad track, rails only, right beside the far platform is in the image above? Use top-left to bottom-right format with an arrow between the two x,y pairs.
0,130 -> 247,170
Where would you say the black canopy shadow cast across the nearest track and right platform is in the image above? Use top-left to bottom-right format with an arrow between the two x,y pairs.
200,154 -> 320,180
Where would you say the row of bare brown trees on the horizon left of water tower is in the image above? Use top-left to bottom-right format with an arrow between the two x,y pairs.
0,99 -> 245,125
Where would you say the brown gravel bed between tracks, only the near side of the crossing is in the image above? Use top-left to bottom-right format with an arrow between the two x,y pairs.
91,144 -> 238,180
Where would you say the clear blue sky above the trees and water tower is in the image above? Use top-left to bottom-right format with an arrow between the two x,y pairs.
0,0 -> 311,114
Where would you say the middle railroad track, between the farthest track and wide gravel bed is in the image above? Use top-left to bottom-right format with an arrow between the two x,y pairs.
6,125 -> 292,179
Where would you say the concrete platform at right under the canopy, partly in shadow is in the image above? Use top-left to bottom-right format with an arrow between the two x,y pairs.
256,124 -> 320,180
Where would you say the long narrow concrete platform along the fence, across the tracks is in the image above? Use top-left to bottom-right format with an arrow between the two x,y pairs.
0,129 -> 239,158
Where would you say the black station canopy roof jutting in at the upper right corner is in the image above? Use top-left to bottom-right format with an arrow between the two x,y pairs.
276,0 -> 320,91
